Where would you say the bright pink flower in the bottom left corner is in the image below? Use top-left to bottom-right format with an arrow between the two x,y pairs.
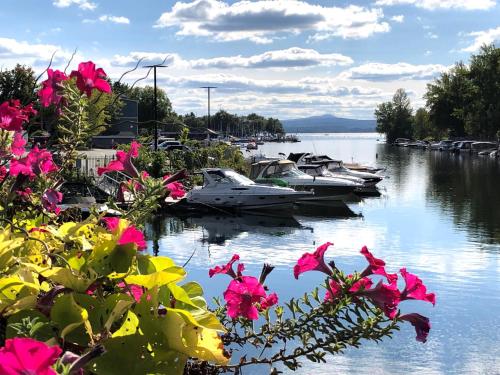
0,337 -> 62,375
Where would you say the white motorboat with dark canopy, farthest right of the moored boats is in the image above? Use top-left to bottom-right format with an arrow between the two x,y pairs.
288,153 -> 383,187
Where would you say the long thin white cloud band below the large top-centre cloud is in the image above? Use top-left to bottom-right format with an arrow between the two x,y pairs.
111,47 -> 353,69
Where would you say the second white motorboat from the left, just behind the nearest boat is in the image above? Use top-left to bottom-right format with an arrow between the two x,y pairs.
250,160 -> 363,201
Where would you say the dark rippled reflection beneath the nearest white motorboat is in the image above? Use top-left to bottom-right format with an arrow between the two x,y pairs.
183,214 -> 302,245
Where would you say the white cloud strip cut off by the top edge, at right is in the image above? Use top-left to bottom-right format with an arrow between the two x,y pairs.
375,0 -> 496,10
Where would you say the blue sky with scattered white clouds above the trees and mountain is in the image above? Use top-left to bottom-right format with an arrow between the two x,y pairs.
0,0 -> 500,119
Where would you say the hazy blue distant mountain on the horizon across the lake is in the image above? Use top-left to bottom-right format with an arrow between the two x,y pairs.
281,115 -> 376,133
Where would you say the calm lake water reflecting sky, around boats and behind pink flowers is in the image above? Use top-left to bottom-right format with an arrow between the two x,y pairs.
147,134 -> 500,375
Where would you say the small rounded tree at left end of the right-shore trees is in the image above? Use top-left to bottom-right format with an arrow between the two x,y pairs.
375,89 -> 413,142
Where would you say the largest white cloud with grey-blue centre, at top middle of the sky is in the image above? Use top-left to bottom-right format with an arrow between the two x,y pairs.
155,0 -> 390,44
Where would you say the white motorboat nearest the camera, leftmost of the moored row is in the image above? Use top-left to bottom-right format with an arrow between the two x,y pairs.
186,168 -> 312,210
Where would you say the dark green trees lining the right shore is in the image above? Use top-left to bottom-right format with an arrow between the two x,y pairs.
375,44 -> 500,142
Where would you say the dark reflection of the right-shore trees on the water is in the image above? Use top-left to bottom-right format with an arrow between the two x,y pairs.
427,152 -> 500,242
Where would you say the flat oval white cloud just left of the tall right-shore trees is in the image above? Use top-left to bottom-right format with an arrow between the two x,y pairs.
342,62 -> 448,81
